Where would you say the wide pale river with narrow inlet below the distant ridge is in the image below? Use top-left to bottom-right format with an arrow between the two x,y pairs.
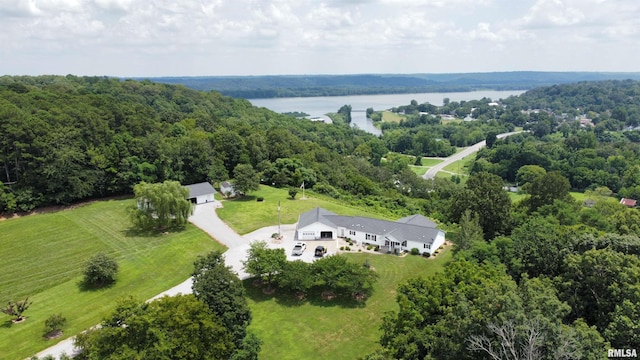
249,90 -> 524,135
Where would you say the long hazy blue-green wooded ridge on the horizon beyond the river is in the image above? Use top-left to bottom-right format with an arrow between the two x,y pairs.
141,71 -> 640,99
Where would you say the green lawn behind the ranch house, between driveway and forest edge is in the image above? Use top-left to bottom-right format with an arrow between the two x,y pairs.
217,185 -> 395,234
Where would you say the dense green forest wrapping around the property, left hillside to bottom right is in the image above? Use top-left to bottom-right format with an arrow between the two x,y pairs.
0,76 -> 640,359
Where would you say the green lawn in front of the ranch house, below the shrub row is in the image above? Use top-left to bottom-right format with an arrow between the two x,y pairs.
245,248 -> 451,359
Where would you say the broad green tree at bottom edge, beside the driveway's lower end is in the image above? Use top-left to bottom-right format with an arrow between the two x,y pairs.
75,295 -> 236,360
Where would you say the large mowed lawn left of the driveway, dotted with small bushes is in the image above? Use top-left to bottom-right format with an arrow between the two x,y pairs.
0,200 -> 224,359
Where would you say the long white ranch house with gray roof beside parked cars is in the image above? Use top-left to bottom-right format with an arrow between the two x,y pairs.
296,207 -> 445,255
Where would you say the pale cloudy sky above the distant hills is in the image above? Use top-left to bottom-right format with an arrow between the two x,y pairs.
0,0 -> 640,77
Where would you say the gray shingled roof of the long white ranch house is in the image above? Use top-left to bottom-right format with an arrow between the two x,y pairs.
298,207 -> 440,244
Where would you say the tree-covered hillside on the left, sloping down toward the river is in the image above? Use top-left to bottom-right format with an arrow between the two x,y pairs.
0,76 -> 380,211
